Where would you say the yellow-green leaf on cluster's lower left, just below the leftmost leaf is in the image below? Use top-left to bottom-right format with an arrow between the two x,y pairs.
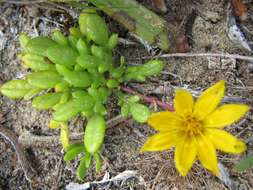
32,92 -> 62,109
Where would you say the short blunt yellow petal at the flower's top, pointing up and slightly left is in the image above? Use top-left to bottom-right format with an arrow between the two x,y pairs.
174,89 -> 194,117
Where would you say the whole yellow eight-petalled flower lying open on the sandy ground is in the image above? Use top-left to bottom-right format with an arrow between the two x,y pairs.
142,80 -> 249,176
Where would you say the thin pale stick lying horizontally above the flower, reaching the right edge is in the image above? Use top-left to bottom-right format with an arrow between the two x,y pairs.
142,53 -> 253,61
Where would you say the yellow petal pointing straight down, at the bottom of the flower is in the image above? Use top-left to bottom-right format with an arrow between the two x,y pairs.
175,137 -> 197,176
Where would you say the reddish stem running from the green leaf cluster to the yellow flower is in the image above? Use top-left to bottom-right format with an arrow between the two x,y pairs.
121,86 -> 174,111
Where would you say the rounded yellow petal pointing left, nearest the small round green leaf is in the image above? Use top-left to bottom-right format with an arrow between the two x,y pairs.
148,111 -> 183,131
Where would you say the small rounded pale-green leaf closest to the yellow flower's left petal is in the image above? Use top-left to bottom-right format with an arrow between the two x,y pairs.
130,103 -> 150,123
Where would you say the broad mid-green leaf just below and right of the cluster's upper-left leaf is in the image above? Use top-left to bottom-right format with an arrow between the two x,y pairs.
46,45 -> 78,67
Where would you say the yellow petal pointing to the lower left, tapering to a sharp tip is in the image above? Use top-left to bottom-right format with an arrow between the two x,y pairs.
141,132 -> 178,152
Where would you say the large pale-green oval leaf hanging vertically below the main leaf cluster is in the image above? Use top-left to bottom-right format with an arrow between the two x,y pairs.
84,115 -> 106,155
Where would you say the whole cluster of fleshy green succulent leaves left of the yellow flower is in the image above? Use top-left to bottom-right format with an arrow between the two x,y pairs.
0,10 -> 164,179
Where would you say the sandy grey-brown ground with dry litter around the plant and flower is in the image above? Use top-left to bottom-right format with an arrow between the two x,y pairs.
0,0 -> 253,190
